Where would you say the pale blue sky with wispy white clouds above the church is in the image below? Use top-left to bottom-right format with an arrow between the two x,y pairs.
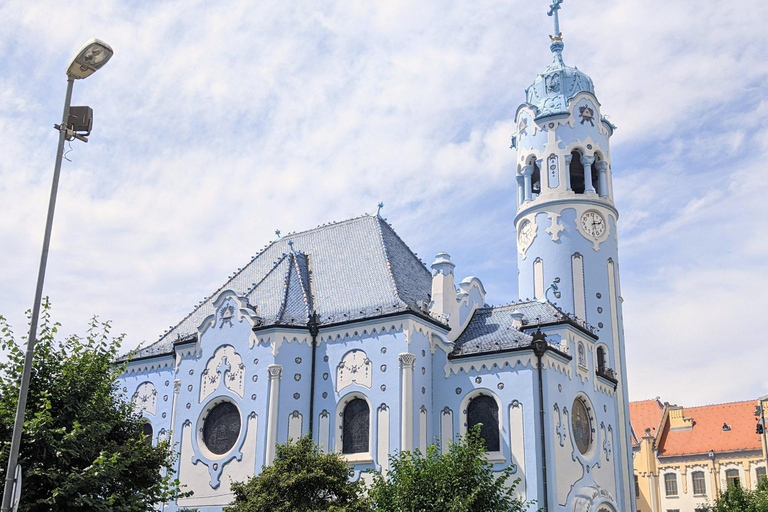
0,0 -> 768,406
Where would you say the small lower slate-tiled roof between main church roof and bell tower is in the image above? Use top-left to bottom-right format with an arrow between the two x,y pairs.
452,301 -> 569,356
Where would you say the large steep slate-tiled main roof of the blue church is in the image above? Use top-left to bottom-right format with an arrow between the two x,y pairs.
129,215 -> 432,357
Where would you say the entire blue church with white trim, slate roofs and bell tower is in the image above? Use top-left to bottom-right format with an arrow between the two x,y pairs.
120,0 -> 635,512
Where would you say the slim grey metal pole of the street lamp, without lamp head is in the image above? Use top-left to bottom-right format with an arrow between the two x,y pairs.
0,77 -> 75,512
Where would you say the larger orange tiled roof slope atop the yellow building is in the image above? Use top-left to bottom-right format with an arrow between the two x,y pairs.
656,400 -> 762,457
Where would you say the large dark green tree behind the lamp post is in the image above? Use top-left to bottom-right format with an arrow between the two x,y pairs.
0,299 -> 186,512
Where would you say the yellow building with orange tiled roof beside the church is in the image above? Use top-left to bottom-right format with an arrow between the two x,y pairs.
630,399 -> 768,512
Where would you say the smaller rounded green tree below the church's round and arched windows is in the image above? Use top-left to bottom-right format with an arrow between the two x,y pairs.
225,436 -> 369,512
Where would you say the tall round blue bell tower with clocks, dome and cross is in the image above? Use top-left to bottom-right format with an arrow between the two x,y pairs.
512,0 -> 634,511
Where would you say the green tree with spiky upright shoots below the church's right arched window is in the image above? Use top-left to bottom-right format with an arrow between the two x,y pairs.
369,427 -> 529,512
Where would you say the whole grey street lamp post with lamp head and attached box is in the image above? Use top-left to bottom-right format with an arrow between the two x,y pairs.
0,38 -> 114,512
